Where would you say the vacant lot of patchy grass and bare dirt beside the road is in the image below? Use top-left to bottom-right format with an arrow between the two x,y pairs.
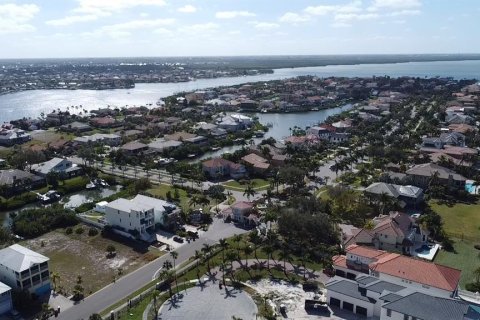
24,226 -> 162,296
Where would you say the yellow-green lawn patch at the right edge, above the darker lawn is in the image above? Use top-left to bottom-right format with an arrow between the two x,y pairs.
430,201 -> 480,242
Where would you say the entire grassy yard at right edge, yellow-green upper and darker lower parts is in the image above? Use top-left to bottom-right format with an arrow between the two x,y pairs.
430,201 -> 480,288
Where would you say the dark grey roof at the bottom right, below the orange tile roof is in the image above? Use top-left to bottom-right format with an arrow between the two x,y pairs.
383,292 -> 472,320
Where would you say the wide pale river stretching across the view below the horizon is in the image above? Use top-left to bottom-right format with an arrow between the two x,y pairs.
0,60 -> 480,123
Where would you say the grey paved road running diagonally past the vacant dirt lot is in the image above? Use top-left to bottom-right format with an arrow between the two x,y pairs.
57,219 -> 246,320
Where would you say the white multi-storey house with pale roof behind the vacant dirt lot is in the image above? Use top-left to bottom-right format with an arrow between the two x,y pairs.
105,198 -> 155,241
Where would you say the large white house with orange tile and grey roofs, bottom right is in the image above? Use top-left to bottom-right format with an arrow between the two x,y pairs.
326,245 -> 468,320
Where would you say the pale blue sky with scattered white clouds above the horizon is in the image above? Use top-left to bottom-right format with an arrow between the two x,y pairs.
0,0 -> 480,58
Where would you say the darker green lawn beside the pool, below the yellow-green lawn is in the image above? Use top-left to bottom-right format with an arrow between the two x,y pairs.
435,239 -> 480,289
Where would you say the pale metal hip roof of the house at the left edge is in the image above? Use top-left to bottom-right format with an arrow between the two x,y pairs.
0,244 -> 50,272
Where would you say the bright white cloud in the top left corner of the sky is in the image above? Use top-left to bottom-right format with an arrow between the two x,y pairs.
0,3 -> 40,34
